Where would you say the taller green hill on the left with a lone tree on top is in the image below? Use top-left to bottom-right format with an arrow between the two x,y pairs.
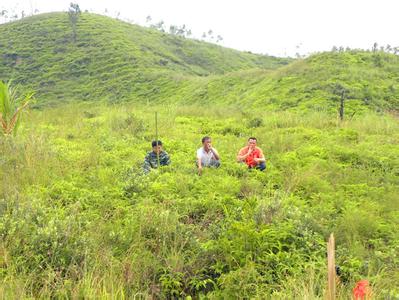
0,13 -> 290,102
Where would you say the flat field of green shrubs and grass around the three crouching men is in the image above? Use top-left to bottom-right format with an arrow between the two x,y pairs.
0,104 -> 399,299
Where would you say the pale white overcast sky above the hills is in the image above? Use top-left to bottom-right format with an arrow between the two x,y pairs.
0,0 -> 399,56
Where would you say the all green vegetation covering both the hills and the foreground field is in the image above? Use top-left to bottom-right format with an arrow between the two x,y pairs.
0,13 -> 399,299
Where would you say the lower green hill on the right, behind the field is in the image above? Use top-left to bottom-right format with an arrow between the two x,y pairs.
175,51 -> 399,115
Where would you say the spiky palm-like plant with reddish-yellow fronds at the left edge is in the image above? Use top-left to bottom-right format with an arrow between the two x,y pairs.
0,81 -> 33,135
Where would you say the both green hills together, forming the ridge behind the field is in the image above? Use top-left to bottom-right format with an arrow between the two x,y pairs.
0,13 -> 399,114
